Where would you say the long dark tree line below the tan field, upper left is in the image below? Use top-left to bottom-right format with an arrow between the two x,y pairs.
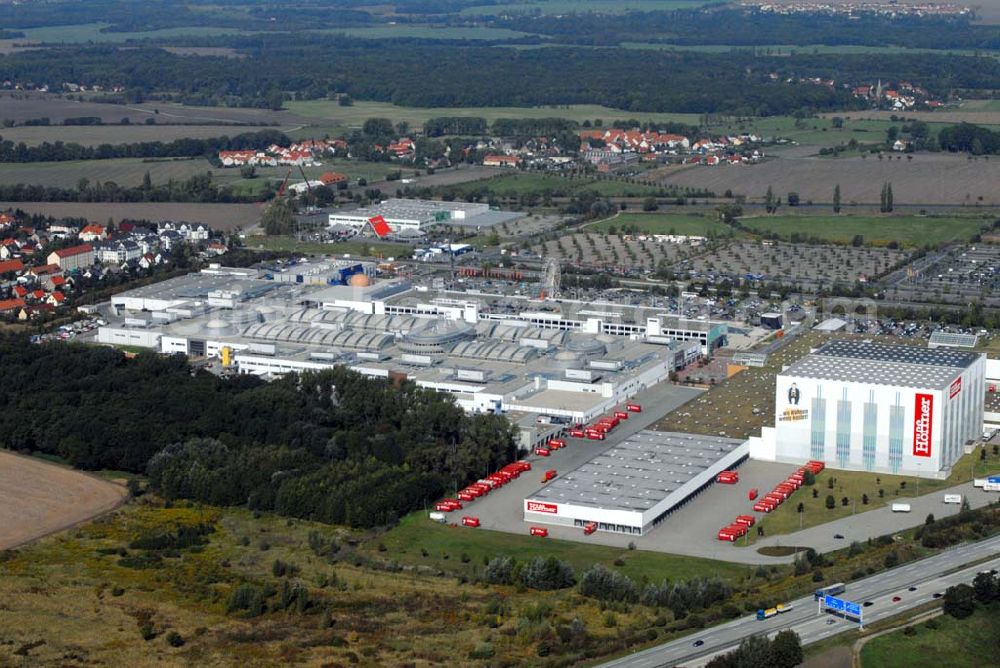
0,130 -> 291,162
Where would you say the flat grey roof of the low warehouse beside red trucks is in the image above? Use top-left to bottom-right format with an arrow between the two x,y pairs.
529,430 -> 743,513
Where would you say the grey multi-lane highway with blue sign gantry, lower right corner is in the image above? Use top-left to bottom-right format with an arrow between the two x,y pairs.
603,536 -> 1000,668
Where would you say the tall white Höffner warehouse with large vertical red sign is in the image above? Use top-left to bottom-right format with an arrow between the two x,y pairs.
751,341 -> 986,478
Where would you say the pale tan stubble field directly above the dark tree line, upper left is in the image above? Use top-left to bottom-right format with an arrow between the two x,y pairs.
0,125 -> 286,146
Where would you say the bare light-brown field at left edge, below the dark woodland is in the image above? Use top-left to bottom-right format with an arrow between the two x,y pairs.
0,450 -> 125,550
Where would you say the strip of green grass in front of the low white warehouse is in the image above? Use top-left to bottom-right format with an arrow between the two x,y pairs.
379,512 -> 749,582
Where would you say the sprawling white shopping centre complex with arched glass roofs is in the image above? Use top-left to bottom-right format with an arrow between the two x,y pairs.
98,260 -> 726,422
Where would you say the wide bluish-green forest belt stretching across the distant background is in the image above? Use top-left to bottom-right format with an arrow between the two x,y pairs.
0,35 -> 1000,116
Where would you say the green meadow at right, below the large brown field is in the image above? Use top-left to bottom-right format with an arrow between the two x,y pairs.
740,215 -> 990,247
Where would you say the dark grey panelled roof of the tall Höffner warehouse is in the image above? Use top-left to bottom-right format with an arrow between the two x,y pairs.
780,340 -> 980,389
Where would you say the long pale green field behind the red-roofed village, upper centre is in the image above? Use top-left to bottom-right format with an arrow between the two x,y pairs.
285,100 -> 698,127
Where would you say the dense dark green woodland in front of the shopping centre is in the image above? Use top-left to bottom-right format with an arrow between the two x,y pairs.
0,337 -> 516,526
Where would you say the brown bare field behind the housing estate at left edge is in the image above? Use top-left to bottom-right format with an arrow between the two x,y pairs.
0,202 -> 260,230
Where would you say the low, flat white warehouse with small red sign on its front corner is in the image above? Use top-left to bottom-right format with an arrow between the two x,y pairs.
524,431 -> 749,535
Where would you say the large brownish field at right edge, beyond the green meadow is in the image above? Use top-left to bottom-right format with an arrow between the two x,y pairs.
660,153 -> 1000,206
